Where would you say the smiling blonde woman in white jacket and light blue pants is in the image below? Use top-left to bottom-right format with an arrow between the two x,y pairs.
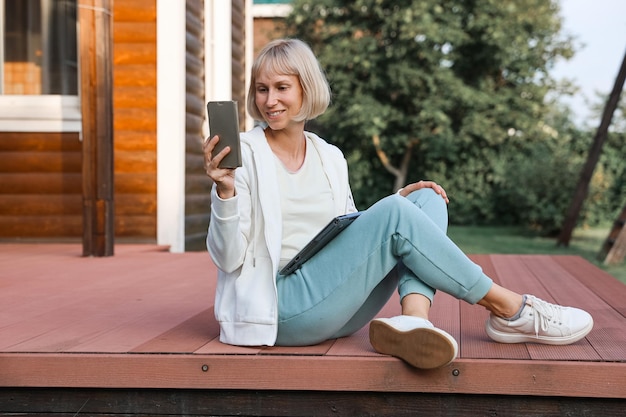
204,39 -> 593,369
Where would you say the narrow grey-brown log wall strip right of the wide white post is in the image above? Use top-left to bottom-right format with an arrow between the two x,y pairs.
185,0 -> 211,251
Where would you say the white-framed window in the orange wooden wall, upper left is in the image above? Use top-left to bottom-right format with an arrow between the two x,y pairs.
0,0 -> 80,131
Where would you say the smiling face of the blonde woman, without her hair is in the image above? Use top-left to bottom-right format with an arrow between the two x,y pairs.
254,72 -> 302,130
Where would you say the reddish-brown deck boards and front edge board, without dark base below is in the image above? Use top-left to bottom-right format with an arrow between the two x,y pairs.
0,245 -> 626,404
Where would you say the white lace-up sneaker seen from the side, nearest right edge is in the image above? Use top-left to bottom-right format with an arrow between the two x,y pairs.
485,295 -> 593,345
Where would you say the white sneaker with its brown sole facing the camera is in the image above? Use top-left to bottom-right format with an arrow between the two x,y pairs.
370,316 -> 459,369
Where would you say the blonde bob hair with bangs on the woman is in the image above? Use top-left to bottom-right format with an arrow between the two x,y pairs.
246,39 -> 330,122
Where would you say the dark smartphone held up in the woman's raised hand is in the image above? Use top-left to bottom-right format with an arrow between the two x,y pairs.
207,101 -> 241,168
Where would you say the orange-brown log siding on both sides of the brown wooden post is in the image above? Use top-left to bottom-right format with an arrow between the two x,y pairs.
0,0 -> 156,241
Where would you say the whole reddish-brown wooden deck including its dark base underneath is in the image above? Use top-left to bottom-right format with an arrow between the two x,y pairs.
0,244 -> 626,416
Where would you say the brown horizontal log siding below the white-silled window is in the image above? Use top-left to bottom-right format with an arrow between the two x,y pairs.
0,132 -> 82,239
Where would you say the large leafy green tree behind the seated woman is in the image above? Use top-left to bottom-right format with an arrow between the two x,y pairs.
286,0 -> 573,223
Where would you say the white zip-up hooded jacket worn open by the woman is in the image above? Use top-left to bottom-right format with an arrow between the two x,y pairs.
207,126 -> 356,346
